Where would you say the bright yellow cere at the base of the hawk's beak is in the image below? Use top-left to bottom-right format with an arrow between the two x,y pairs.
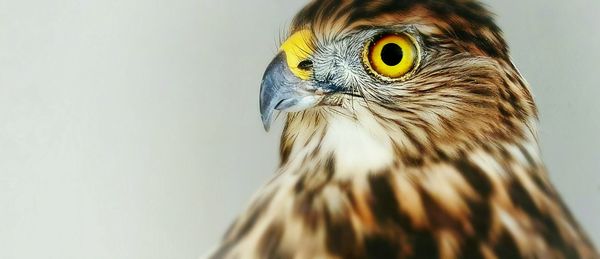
281,29 -> 313,80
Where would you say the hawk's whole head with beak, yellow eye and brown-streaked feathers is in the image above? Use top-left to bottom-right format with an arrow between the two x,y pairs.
260,0 -> 536,170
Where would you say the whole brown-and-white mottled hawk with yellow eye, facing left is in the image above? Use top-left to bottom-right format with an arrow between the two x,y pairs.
209,0 -> 600,259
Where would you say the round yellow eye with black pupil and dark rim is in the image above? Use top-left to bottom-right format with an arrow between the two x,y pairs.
363,34 -> 420,81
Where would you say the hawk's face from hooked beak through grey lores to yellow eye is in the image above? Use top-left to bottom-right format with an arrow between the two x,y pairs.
260,26 -> 423,128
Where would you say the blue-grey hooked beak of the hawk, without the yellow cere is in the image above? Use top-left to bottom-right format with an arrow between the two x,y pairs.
260,52 -> 342,131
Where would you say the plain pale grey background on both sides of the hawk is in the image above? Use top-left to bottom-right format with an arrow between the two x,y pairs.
0,0 -> 600,259
